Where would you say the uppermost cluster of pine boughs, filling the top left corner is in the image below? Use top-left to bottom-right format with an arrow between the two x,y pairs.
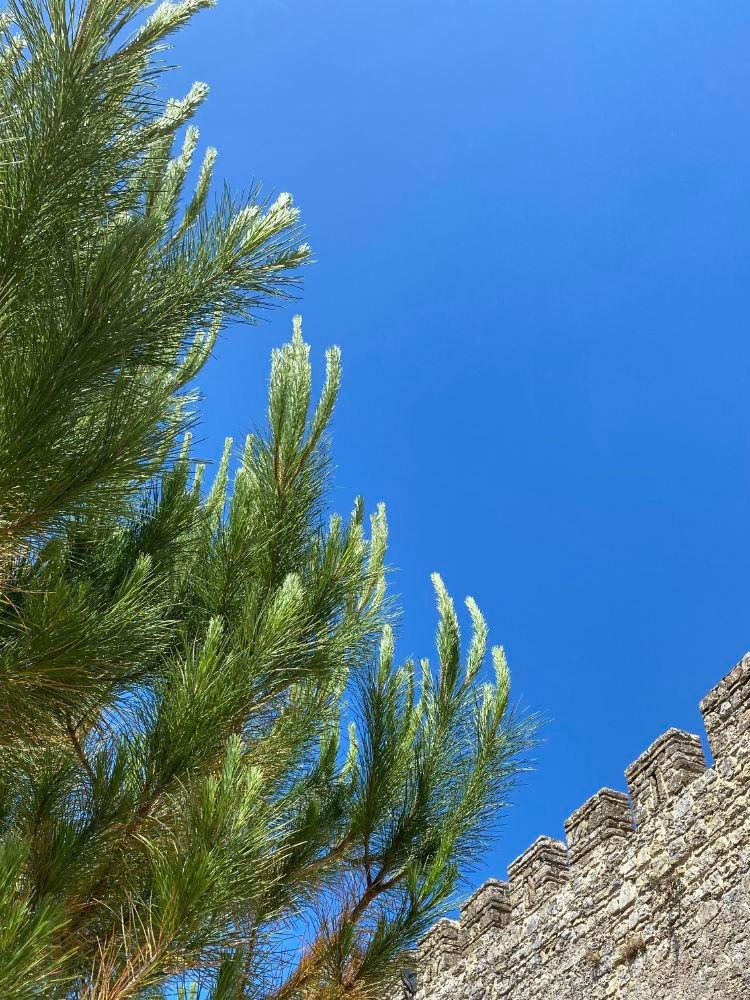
0,0 -> 308,554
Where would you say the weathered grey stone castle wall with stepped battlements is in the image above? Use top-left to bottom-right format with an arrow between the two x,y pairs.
397,654 -> 750,1000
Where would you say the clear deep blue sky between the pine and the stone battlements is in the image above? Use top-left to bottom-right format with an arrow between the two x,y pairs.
170,0 -> 750,881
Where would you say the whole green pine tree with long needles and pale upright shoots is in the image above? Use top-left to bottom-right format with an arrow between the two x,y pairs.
0,0 -> 530,1000
